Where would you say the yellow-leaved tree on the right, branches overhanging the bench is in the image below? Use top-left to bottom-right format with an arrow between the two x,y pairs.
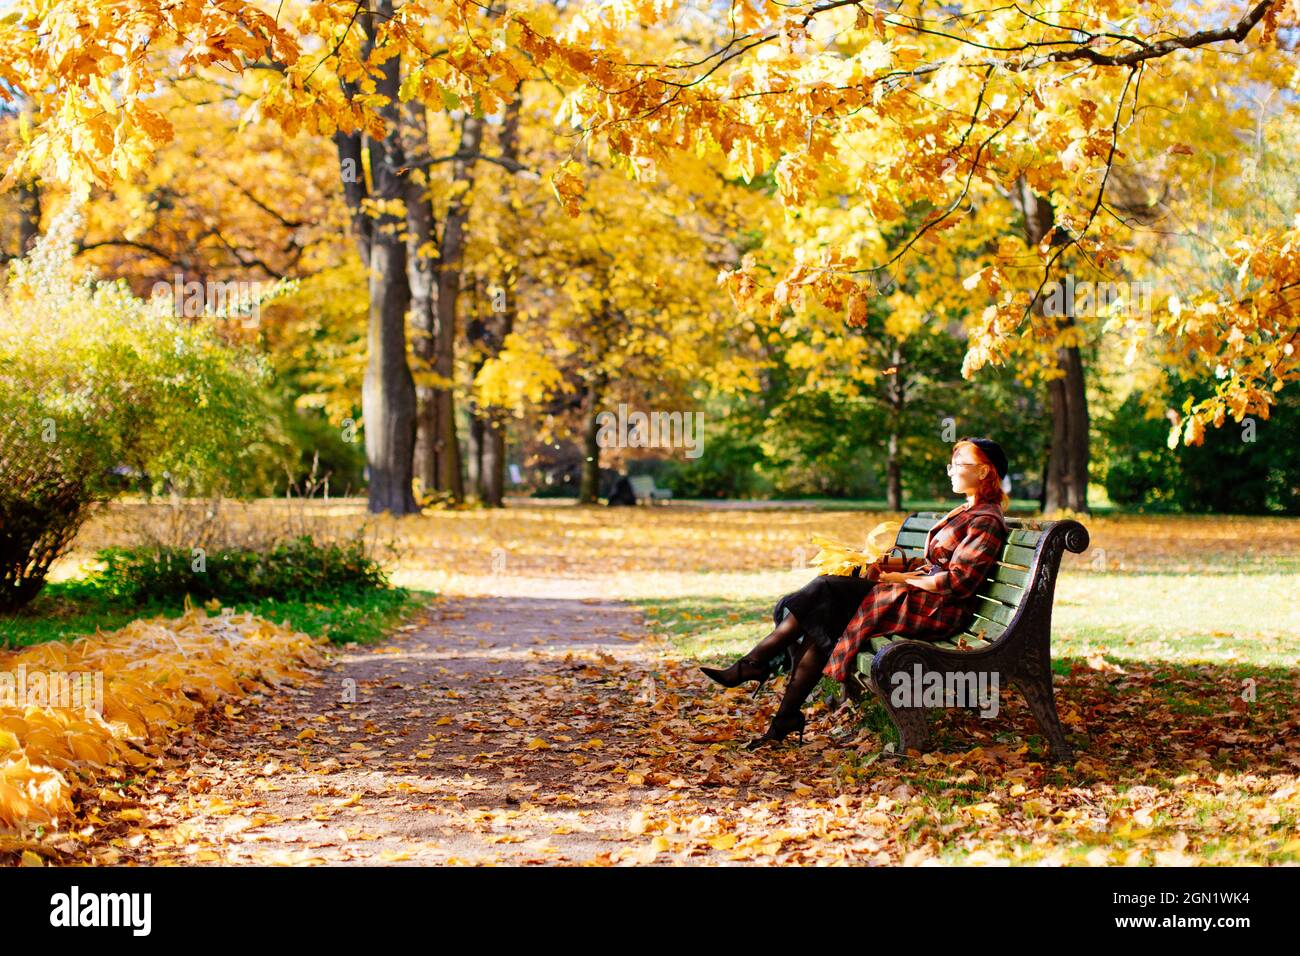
533,0 -> 1297,507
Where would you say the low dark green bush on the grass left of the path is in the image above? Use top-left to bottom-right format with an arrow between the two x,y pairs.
86,535 -> 389,604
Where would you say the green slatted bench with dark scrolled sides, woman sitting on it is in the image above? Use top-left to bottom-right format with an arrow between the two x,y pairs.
777,511 -> 1088,761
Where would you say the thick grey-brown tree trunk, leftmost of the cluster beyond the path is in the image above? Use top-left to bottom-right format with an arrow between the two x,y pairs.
361,0 -> 419,515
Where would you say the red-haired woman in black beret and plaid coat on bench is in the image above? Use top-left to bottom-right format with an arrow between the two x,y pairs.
699,438 -> 1008,750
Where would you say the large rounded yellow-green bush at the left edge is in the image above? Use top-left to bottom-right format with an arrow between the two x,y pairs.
0,211 -> 283,613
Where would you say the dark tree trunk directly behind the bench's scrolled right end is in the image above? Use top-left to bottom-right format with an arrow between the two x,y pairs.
1015,178 -> 1091,512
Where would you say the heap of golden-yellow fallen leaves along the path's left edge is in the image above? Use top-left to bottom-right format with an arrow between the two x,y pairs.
0,609 -> 325,856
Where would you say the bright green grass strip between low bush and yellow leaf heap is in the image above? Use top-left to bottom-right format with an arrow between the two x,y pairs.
0,580 -> 432,646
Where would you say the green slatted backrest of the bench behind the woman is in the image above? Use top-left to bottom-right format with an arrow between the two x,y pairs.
896,511 -> 1088,648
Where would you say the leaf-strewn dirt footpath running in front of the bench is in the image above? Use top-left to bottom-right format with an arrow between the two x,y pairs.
139,581 -> 889,865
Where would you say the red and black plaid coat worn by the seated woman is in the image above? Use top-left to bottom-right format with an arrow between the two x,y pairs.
822,502 -> 1008,683
